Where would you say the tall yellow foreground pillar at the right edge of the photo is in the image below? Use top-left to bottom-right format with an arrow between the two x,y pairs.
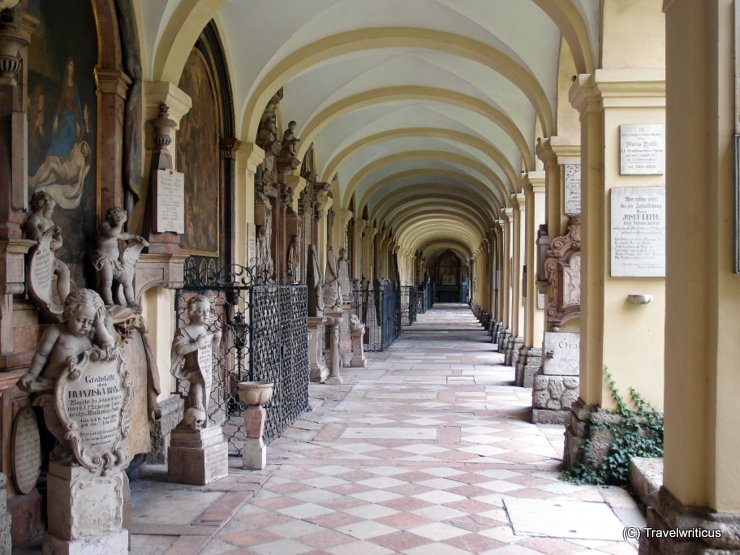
640,0 -> 740,555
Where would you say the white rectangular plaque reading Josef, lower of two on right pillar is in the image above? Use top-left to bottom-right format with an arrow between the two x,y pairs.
611,186 -> 665,277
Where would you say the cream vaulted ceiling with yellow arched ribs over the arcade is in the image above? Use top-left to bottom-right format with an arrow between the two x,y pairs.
138,0 -> 601,256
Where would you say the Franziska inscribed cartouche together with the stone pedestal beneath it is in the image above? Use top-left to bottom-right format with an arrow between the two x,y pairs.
44,346 -> 133,555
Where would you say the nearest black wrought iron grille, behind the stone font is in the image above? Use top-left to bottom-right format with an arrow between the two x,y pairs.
176,258 -> 309,455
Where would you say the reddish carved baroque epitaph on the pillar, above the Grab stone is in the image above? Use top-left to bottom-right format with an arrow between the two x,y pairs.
545,216 -> 581,328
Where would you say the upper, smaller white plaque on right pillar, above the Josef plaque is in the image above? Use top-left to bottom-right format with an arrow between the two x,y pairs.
619,123 -> 665,175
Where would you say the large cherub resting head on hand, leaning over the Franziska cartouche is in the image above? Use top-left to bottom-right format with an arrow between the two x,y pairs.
18,289 -> 115,460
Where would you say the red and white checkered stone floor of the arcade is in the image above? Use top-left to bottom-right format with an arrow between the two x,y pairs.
18,305 -> 644,555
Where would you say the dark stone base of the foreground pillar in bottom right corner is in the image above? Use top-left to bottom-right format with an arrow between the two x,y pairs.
640,487 -> 740,555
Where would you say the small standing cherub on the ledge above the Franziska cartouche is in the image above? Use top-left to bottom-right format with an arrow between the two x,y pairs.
93,207 -> 149,307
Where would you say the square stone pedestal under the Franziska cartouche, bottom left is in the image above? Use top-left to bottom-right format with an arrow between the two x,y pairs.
43,462 -> 128,555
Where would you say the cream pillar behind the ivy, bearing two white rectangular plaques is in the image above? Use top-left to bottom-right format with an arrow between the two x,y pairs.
566,69 -> 666,462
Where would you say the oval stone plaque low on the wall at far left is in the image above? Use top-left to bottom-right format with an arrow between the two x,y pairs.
11,407 -> 41,493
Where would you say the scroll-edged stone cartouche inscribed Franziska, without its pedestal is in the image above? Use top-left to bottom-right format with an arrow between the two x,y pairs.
54,347 -> 132,472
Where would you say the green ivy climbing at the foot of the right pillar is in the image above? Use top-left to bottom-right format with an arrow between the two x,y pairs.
561,368 -> 663,486
